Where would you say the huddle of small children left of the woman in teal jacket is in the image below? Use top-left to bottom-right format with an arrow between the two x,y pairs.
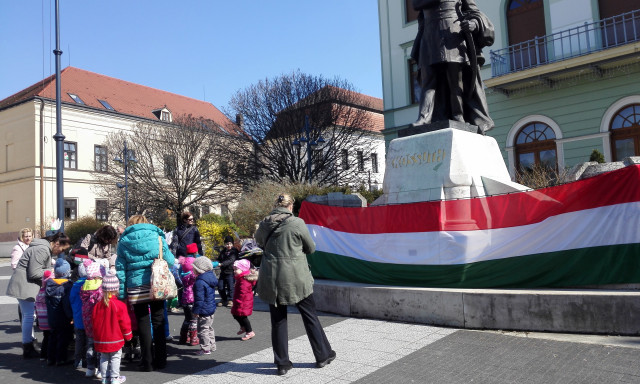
35,249 -> 133,384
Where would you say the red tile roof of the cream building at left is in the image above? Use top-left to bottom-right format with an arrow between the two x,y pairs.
0,67 -> 237,129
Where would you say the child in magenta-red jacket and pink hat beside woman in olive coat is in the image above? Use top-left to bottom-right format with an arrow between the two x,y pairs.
231,259 -> 258,341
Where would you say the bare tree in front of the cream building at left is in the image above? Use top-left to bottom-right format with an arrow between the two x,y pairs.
94,116 -> 252,220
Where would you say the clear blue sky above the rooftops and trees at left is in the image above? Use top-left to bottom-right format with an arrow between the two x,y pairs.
0,0 -> 382,108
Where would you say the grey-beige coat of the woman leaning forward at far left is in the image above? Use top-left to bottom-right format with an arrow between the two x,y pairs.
7,239 -> 52,301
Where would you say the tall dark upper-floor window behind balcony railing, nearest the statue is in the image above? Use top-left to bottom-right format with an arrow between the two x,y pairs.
507,0 -> 547,69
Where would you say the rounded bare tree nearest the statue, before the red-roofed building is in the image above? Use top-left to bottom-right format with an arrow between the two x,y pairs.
229,72 -> 382,185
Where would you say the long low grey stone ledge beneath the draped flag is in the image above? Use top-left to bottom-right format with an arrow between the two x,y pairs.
314,280 -> 640,335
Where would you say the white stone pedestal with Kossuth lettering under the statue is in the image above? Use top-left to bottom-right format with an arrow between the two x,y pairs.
375,124 -> 528,206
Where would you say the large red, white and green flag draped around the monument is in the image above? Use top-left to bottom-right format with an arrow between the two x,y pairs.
300,165 -> 640,288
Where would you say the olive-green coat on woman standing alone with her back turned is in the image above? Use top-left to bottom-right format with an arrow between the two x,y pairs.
255,208 -> 316,305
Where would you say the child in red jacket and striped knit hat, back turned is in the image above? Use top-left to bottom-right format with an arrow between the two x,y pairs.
93,272 -> 132,384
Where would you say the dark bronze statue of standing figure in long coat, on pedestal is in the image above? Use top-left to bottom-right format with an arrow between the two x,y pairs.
411,0 -> 494,134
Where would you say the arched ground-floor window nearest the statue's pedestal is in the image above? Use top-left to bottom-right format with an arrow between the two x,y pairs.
515,122 -> 558,171
